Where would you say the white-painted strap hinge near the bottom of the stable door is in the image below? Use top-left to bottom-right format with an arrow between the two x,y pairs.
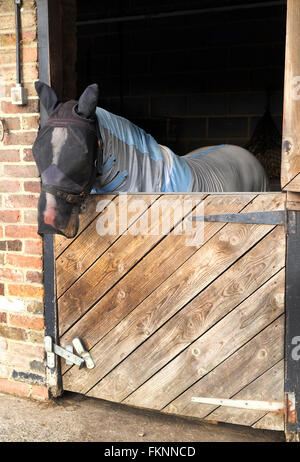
191,397 -> 285,413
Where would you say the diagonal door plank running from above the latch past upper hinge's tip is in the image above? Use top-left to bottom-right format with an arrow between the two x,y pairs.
61,196 -> 252,349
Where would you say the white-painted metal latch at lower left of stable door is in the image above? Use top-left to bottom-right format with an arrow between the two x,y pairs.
45,336 -> 95,369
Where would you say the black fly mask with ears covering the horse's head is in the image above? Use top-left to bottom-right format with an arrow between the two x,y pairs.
33,82 -> 100,238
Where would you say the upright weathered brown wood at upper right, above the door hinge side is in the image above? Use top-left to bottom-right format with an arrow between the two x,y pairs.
281,0 -> 300,191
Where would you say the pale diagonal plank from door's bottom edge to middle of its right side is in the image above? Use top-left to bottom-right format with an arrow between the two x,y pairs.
116,270 -> 284,409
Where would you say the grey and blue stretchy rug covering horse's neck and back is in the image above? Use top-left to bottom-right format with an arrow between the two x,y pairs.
92,107 -> 266,193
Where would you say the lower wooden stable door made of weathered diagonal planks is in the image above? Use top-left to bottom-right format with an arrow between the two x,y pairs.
56,193 -> 286,430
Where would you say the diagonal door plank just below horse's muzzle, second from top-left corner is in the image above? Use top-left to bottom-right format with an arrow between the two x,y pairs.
56,195 -> 159,298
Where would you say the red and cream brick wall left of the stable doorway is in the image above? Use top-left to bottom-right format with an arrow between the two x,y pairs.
0,0 -> 48,399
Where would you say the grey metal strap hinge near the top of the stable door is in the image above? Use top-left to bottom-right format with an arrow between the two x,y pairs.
191,210 -> 296,233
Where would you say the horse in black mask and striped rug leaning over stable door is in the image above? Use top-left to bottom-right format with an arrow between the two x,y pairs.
33,81 -> 268,237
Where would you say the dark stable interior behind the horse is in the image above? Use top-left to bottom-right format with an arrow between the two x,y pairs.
76,0 -> 286,190
